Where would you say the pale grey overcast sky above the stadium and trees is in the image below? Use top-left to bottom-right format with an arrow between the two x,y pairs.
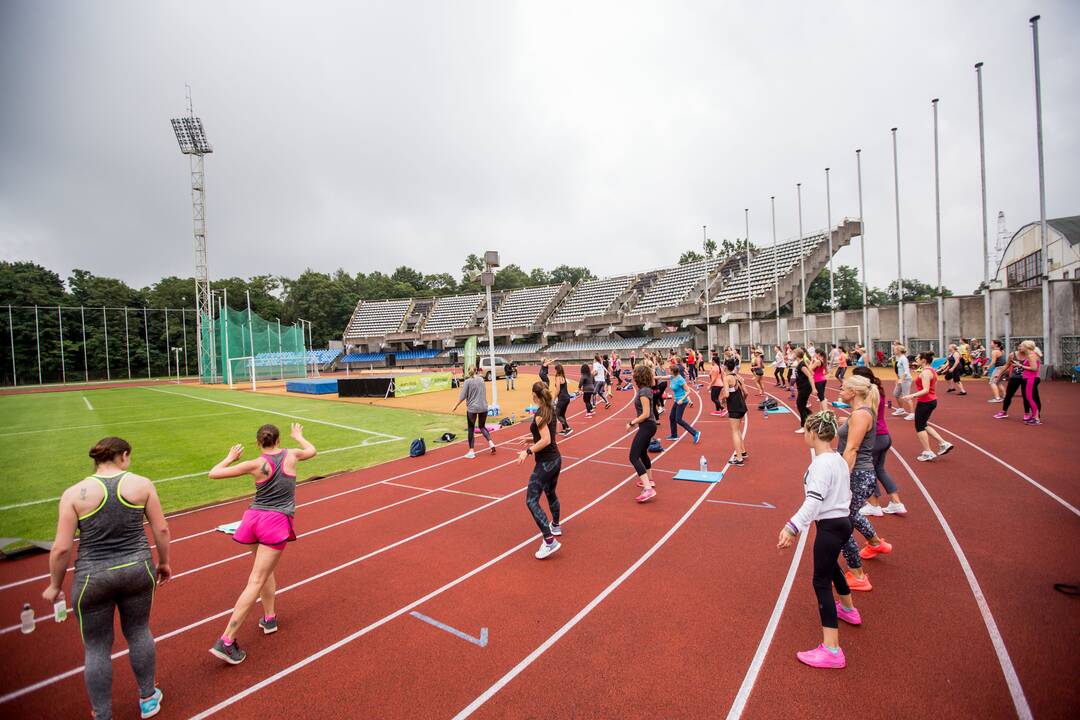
0,0 -> 1080,293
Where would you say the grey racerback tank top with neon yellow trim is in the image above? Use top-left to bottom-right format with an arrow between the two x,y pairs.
75,473 -> 150,572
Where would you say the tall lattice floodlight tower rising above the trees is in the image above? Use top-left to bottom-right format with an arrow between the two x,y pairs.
172,85 -> 217,382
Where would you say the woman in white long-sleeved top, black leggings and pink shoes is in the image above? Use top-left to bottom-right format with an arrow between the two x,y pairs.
777,410 -> 863,669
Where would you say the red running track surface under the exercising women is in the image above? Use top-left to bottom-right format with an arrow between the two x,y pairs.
0,375 -> 1080,720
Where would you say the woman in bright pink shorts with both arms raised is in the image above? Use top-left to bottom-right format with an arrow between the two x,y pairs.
210,423 -> 315,665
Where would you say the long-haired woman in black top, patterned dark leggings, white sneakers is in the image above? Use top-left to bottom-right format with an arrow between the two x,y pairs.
517,379 -> 565,560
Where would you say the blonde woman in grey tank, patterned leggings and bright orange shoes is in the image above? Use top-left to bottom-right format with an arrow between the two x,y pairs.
836,375 -> 892,590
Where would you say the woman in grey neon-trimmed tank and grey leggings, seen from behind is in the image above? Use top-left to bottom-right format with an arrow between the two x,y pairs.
41,437 -> 172,720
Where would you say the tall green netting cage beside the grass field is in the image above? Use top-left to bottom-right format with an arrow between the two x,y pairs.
201,308 -> 308,383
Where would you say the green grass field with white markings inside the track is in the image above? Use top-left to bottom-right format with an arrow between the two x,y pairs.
0,385 -> 461,540
